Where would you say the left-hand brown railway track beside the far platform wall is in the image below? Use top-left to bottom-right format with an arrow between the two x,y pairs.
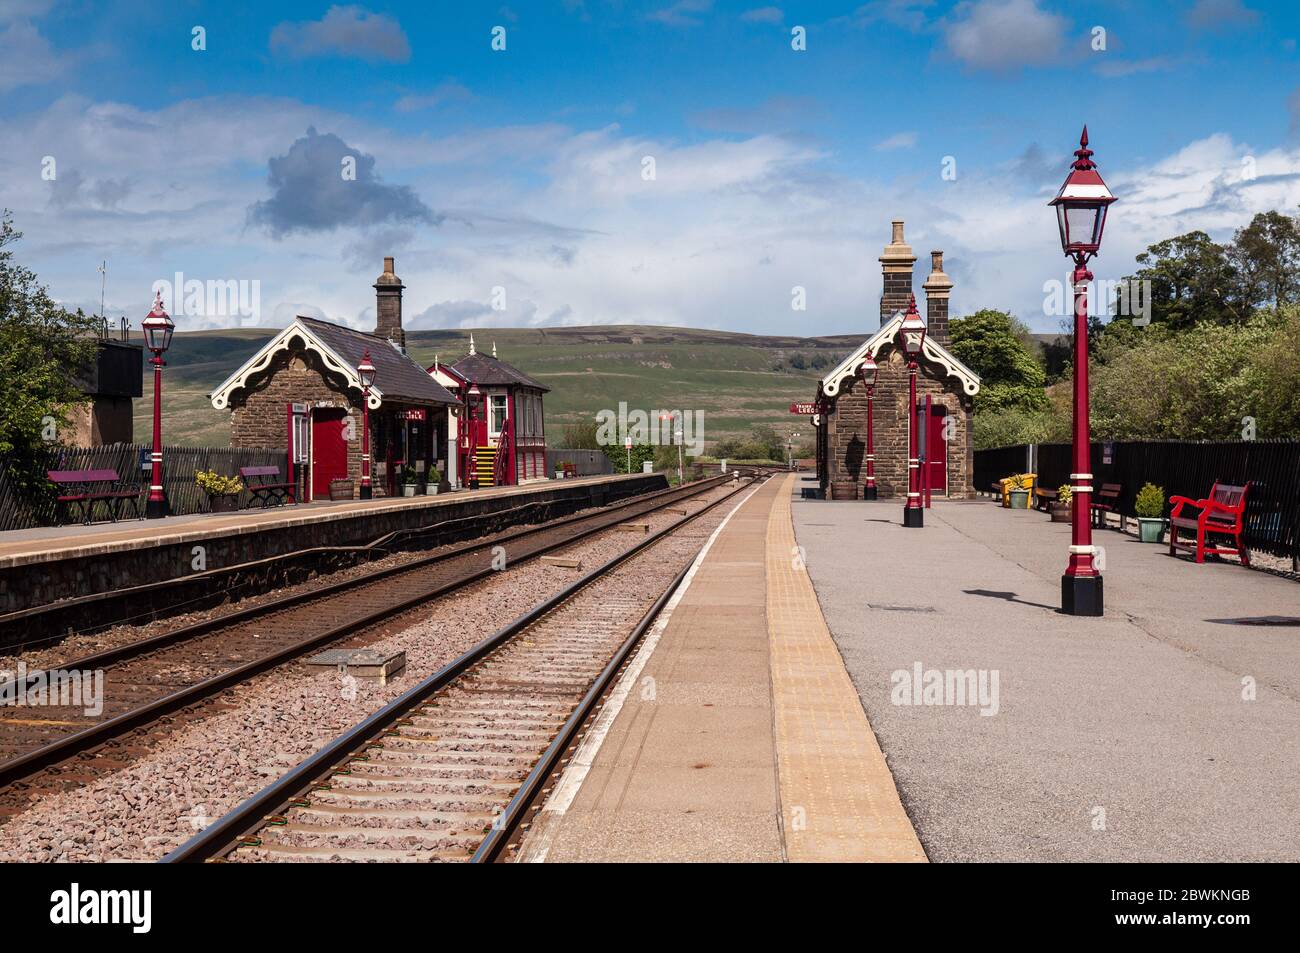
0,478 -> 743,822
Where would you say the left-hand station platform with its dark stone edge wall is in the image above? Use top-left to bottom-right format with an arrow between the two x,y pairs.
0,473 -> 667,616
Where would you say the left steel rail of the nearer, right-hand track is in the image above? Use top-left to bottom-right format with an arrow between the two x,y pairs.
161,482 -> 751,863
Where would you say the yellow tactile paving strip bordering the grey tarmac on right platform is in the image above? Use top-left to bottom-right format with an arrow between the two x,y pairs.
766,473 -> 926,862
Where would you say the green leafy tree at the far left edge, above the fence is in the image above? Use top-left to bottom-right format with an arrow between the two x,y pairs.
0,209 -> 99,498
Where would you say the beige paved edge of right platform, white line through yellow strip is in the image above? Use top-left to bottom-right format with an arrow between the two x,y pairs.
520,475 -> 926,862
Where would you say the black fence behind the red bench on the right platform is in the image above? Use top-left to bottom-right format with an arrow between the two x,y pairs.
975,439 -> 1300,564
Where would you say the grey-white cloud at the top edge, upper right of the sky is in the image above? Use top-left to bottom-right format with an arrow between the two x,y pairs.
943,0 -> 1069,70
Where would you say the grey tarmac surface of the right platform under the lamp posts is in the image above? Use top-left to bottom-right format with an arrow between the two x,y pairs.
793,491 -> 1300,861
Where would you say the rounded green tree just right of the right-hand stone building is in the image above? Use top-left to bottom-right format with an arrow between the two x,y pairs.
950,308 -> 1047,413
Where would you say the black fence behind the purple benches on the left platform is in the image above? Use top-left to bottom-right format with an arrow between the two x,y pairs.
0,443 -> 285,530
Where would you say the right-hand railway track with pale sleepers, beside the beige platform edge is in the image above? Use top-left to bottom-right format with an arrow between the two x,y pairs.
164,481 -> 753,862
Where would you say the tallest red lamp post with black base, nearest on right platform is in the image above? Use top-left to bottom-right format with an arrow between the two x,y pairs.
1048,126 -> 1115,615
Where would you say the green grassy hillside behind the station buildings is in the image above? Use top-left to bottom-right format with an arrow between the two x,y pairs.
135,325 -> 861,446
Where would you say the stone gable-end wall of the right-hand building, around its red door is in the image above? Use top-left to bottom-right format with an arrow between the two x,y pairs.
827,345 -> 975,499
